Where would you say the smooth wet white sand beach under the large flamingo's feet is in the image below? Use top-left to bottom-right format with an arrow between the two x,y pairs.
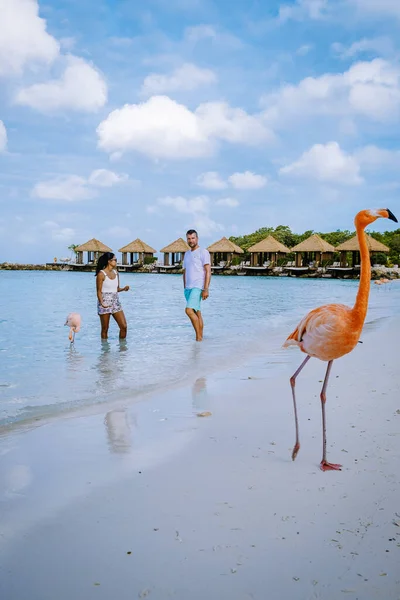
0,318 -> 400,600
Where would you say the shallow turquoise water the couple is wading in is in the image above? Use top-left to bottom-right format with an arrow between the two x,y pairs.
0,271 -> 400,426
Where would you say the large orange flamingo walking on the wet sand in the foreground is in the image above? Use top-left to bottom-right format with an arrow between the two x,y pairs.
284,208 -> 397,471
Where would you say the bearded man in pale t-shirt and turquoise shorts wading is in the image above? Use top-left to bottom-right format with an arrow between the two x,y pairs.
183,229 -> 211,342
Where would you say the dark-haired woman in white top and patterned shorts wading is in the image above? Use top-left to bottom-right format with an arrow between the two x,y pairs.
96,252 -> 129,340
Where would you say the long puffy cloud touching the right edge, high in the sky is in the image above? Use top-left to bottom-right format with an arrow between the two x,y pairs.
264,58 -> 400,127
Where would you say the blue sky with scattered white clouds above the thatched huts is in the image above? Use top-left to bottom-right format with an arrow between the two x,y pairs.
0,0 -> 400,262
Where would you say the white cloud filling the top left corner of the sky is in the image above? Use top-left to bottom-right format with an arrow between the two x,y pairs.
0,0 -> 60,75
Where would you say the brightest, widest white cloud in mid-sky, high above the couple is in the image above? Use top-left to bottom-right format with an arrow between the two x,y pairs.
97,96 -> 273,159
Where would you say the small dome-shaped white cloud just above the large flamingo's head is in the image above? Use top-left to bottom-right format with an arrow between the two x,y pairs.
279,142 -> 363,185
